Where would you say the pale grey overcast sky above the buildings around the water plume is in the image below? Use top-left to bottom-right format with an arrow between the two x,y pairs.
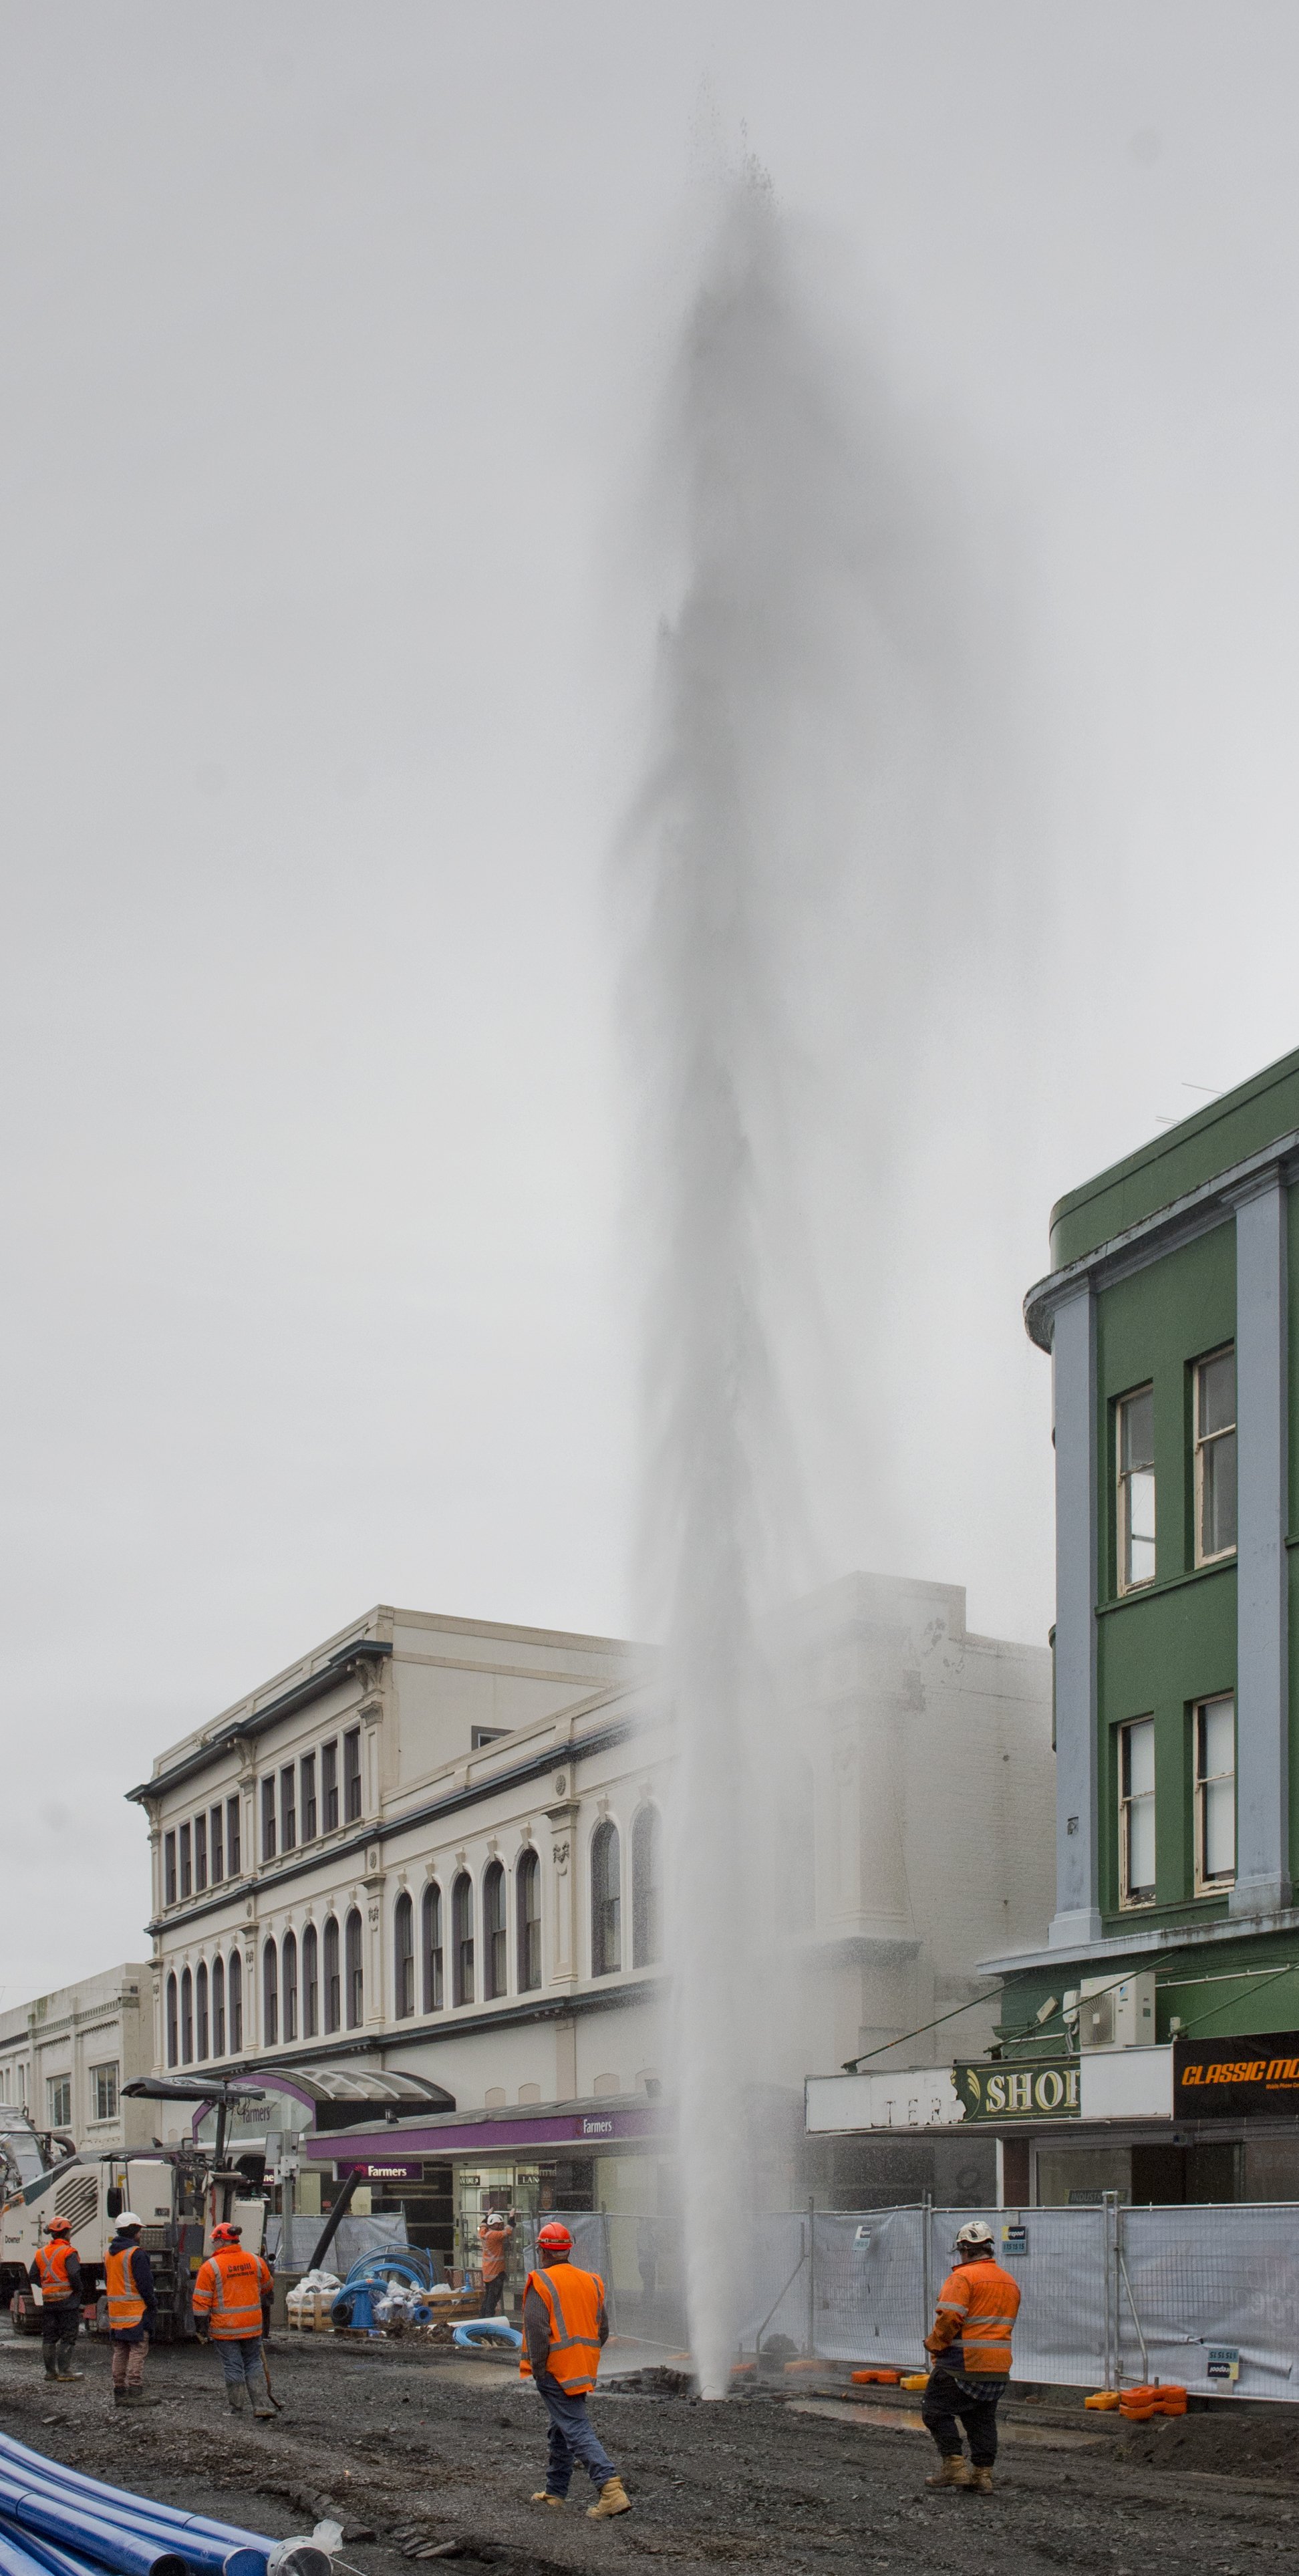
0,0 -> 1299,2004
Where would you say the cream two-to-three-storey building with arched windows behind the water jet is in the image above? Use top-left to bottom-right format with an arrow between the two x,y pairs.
132,1576 -> 1052,2208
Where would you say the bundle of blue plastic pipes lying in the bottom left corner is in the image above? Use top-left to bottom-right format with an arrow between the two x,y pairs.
0,2434 -> 330,2576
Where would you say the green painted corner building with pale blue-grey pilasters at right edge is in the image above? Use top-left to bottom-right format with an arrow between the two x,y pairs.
987,1054 -> 1299,2200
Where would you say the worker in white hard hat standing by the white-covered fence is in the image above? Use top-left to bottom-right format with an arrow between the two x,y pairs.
920,2218 -> 1020,2496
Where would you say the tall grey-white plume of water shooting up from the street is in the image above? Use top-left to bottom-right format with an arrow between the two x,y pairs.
621,168 -> 1015,2396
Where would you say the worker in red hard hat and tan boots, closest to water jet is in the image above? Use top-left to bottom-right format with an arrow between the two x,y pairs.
518,2218 -> 631,2522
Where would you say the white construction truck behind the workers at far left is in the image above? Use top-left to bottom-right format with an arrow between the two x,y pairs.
0,2076 -> 265,2341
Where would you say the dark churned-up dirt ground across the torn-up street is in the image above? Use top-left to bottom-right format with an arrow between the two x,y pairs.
0,2336 -> 1299,2576
